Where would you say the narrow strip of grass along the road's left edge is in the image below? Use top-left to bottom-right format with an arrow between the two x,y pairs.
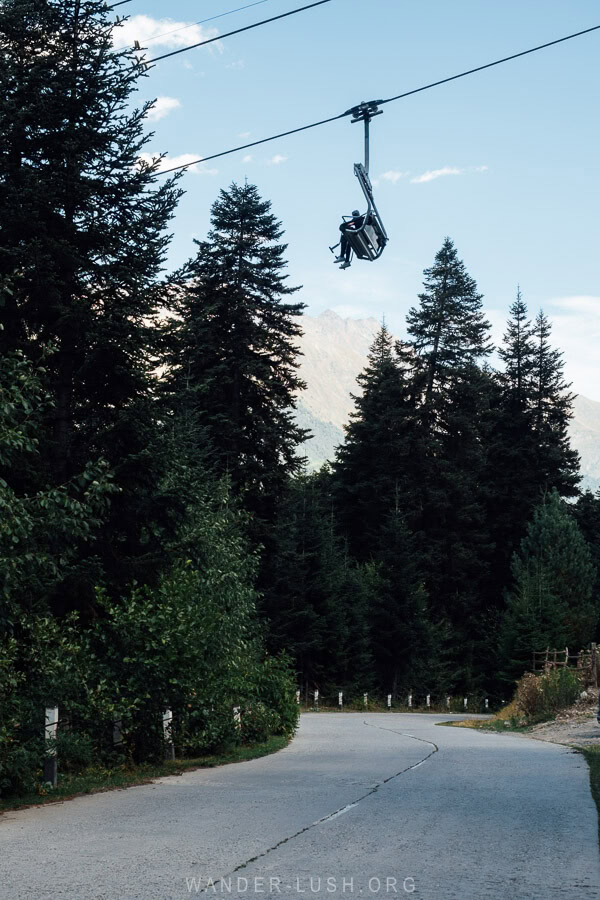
0,736 -> 289,814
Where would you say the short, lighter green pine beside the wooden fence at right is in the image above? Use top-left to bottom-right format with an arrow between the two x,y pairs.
501,490 -> 600,680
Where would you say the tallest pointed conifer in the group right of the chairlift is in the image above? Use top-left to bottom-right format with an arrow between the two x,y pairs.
407,238 -> 494,689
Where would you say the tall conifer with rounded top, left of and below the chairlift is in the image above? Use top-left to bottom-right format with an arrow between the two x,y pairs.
167,184 -> 305,519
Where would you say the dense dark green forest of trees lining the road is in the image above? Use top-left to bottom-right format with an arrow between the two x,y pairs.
0,0 -> 600,793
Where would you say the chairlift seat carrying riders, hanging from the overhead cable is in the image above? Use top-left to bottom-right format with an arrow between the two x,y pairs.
329,100 -> 388,268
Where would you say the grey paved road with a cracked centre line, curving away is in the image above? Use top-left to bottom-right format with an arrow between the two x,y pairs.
0,713 -> 600,900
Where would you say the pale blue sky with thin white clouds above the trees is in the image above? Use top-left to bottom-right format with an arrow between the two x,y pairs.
120,0 -> 600,400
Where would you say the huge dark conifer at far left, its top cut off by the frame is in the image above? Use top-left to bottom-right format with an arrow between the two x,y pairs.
0,0 -> 179,593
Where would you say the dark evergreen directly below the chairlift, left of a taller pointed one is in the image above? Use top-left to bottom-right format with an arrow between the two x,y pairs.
331,325 -> 432,694
